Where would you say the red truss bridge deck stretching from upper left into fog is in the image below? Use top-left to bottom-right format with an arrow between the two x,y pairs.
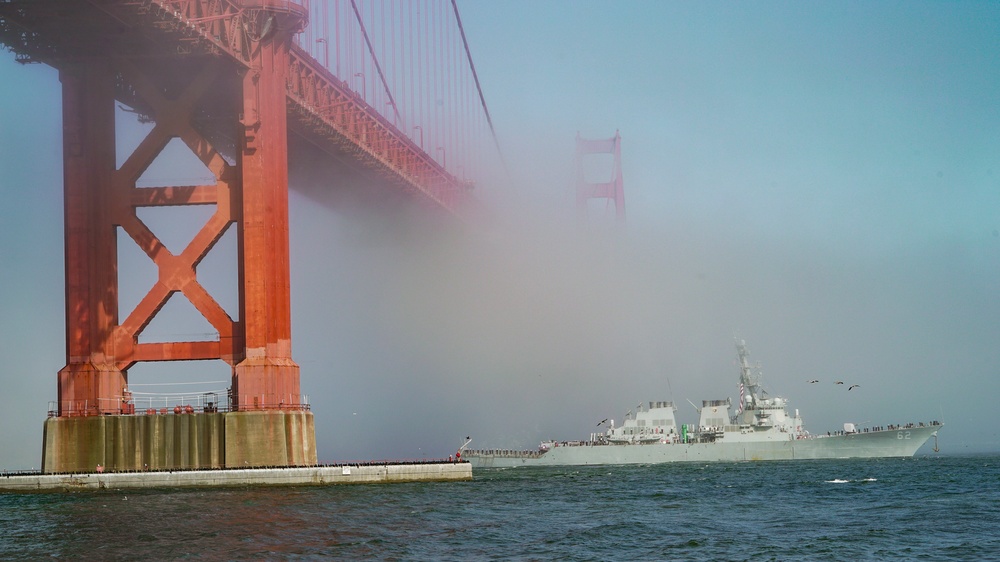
0,0 -> 471,216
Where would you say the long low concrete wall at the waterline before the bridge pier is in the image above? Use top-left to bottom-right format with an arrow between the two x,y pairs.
0,462 -> 472,493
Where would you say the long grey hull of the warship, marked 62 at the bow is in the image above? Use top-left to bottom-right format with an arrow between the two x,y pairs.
462,425 -> 942,468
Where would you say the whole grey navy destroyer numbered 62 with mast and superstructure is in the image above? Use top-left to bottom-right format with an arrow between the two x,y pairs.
460,340 -> 942,468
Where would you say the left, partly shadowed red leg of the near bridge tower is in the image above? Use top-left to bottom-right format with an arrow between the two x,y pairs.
58,60 -> 126,416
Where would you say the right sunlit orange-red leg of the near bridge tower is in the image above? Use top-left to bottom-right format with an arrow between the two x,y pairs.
233,23 -> 300,410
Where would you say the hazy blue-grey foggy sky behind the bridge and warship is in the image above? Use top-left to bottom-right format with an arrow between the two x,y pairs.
0,1 -> 1000,469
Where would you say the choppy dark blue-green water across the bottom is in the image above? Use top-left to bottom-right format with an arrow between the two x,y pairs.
0,455 -> 1000,561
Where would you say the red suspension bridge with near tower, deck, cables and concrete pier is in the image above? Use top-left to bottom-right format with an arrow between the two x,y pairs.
0,0 -> 620,471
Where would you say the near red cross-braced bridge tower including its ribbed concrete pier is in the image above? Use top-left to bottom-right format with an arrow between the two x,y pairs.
42,4 -> 316,472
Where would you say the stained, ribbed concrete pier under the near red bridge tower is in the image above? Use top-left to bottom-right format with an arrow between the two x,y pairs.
42,410 -> 317,474
